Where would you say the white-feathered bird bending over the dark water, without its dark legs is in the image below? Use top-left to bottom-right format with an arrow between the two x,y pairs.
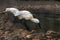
5,8 -> 39,23
